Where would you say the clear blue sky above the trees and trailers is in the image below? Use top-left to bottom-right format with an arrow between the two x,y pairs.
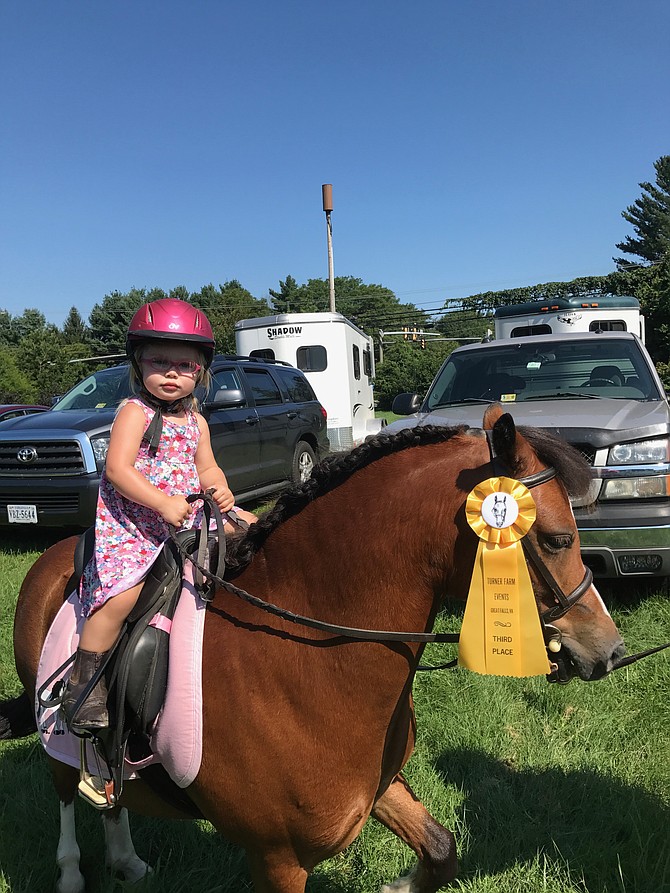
0,0 -> 670,325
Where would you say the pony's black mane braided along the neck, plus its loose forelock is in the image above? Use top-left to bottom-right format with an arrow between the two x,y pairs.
226,425 -> 591,579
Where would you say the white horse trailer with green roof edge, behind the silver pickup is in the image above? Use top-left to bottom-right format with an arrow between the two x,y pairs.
494,295 -> 644,343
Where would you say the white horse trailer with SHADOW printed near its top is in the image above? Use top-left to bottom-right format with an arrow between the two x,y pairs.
235,313 -> 382,450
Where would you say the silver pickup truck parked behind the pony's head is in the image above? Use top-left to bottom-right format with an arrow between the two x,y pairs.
386,332 -> 670,578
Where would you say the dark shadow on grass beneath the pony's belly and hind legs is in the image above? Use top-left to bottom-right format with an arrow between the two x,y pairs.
0,735 -> 347,893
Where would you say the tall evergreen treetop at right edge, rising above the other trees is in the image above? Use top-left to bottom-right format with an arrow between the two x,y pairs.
614,155 -> 670,270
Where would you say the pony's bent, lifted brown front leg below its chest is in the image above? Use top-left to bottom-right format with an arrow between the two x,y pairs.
372,774 -> 458,893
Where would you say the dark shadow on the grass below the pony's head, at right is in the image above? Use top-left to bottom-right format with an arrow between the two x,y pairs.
436,750 -> 670,893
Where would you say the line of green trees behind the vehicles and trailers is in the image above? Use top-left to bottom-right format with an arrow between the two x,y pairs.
0,155 -> 670,409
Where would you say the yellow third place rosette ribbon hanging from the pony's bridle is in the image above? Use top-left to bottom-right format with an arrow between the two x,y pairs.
458,477 -> 550,676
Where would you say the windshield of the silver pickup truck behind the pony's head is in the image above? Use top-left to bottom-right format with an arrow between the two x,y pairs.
426,336 -> 663,410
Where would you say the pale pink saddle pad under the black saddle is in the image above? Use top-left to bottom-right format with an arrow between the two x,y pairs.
35,563 -> 205,788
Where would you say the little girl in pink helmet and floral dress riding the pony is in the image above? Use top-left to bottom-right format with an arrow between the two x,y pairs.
62,298 -> 257,734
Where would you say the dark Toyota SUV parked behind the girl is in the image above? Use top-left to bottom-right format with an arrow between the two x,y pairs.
0,356 -> 329,527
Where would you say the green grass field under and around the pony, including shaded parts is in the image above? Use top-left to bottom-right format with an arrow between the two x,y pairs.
0,534 -> 670,893
